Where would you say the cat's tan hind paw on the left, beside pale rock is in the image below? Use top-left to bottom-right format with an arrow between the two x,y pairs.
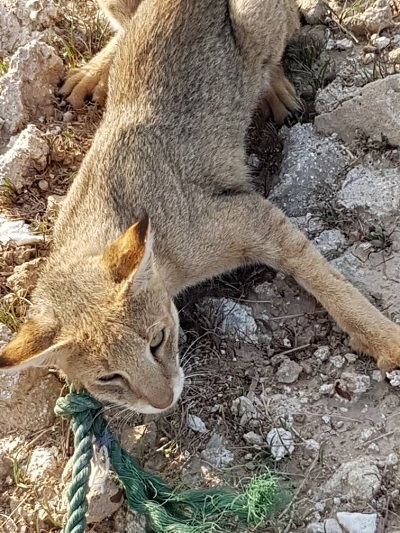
60,62 -> 108,109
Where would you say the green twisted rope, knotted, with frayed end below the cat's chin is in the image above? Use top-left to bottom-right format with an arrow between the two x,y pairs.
55,389 -> 284,533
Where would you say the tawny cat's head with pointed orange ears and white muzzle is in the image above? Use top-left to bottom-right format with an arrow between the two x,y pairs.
0,217 -> 184,413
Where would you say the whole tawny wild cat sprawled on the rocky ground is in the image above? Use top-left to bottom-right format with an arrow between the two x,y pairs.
0,0 -> 400,413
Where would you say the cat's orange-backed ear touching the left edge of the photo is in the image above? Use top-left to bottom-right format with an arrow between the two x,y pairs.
0,319 -> 69,370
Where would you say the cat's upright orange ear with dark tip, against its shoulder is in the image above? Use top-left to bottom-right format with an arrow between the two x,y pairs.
103,215 -> 153,290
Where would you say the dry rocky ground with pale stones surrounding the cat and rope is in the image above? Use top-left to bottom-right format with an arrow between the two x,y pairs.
0,0 -> 400,533
